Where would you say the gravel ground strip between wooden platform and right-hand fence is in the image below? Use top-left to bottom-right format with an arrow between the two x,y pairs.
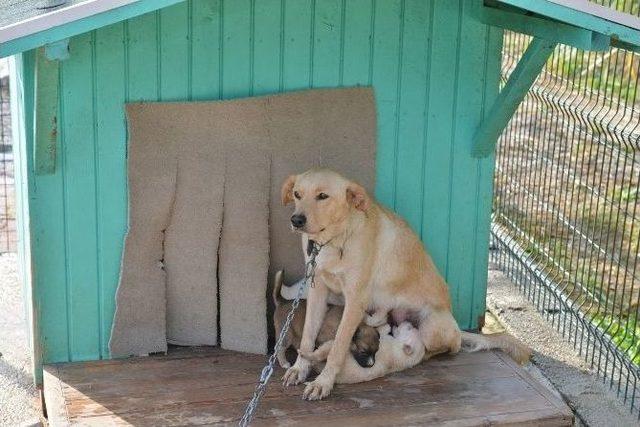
487,269 -> 640,427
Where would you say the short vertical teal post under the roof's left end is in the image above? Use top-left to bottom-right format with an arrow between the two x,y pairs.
33,47 -> 60,175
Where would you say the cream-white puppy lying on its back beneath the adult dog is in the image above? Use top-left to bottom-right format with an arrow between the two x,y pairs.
299,322 -> 424,384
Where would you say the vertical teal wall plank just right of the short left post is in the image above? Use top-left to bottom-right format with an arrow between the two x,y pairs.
60,33 -> 104,360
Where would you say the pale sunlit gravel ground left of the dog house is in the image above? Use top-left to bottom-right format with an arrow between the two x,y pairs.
0,254 -> 40,426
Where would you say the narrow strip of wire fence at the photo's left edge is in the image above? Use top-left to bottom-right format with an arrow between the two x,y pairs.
0,72 -> 17,253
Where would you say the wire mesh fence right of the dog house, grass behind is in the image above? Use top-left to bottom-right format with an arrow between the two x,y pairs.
491,15 -> 640,416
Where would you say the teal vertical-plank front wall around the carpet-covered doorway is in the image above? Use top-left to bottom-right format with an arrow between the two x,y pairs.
15,0 -> 501,368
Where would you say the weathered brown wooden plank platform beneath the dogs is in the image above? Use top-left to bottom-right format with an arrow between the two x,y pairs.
44,349 -> 572,427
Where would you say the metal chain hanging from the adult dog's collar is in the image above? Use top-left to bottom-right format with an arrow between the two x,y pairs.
239,242 -> 323,427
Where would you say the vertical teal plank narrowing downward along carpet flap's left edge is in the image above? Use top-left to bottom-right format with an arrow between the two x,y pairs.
93,23 -> 128,358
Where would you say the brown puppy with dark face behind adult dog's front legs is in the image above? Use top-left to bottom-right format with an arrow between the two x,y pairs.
273,270 -> 380,369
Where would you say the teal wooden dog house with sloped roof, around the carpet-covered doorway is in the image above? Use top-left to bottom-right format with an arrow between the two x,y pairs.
0,0 -> 640,424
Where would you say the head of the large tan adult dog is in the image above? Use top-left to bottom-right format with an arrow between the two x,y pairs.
282,170 -> 371,241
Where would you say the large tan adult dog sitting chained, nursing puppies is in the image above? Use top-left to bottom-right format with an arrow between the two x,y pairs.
282,170 -> 528,400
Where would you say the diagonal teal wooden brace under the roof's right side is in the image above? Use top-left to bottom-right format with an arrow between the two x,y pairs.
471,38 -> 556,157
